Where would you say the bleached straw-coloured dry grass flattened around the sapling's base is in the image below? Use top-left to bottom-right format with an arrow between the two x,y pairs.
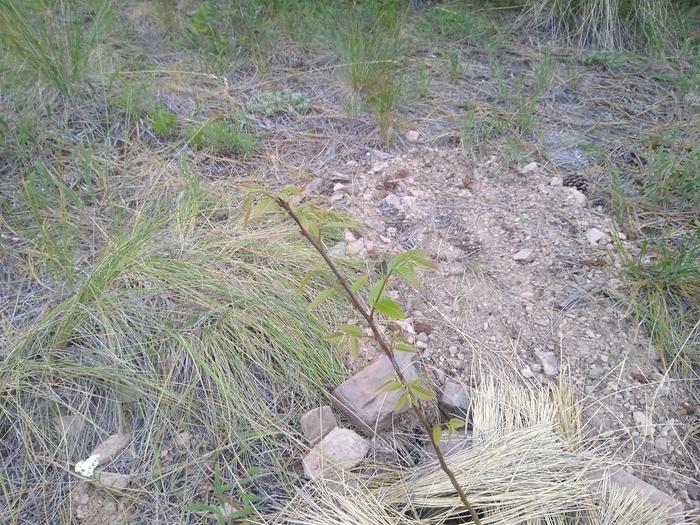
275,377 -> 666,525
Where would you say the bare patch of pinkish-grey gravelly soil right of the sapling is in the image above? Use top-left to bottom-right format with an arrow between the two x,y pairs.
309,145 -> 700,508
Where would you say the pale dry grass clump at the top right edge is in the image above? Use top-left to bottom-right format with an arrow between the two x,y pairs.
519,0 -> 675,51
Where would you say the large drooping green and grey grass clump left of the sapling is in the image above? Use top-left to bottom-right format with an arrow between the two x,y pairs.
0,178 -> 344,523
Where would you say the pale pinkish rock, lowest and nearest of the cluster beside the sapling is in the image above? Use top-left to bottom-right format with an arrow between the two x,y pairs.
303,427 -> 369,479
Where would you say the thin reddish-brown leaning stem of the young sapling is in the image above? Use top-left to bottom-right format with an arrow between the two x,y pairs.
274,197 -> 481,525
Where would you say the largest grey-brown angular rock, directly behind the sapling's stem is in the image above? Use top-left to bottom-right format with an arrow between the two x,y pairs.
332,352 -> 418,435
